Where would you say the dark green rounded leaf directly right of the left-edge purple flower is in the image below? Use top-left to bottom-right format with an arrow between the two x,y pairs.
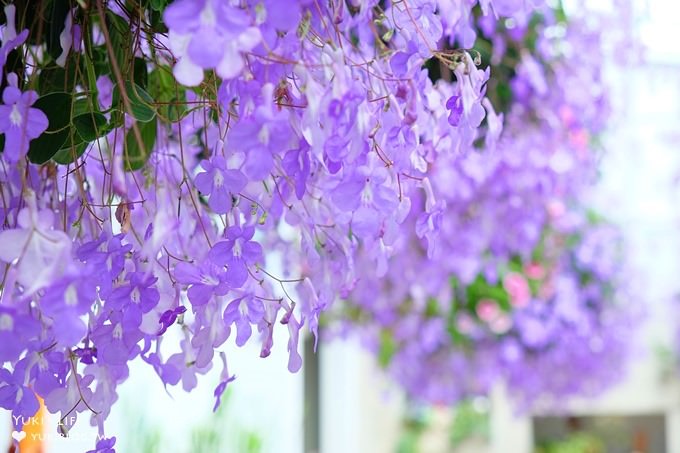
28,92 -> 73,164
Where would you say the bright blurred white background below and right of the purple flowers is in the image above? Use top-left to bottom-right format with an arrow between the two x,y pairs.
0,0 -> 680,453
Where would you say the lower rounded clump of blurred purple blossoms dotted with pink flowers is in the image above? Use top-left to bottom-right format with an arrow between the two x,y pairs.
351,213 -> 635,410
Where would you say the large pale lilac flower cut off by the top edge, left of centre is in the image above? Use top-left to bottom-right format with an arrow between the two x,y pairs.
164,0 -> 262,86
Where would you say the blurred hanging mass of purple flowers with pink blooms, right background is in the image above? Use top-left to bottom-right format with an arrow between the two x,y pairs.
329,3 -> 632,408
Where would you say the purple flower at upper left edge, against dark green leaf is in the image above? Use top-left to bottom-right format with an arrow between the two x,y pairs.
0,74 -> 49,163
